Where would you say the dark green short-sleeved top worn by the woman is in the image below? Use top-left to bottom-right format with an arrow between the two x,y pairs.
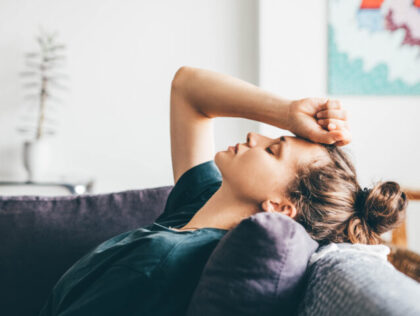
40,160 -> 227,316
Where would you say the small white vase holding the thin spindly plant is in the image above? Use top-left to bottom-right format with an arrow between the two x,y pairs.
23,138 -> 51,181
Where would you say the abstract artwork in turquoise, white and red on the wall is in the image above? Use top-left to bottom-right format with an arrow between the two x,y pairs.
328,0 -> 420,95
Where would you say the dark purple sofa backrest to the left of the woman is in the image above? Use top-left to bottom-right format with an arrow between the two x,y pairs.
0,186 -> 172,316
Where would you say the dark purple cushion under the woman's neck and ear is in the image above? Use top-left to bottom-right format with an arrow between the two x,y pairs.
187,213 -> 318,316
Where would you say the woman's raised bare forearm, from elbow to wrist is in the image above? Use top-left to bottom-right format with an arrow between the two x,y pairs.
172,67 -> 291,129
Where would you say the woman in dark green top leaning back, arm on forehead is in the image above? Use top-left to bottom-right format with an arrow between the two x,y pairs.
41,67 -> 407,316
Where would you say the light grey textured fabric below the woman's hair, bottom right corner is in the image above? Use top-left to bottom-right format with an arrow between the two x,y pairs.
298,243 -> 420,316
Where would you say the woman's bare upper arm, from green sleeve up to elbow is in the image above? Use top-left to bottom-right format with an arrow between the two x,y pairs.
170,67 -> 214,183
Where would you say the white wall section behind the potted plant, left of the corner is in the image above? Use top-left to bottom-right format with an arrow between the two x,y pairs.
0,0 -> 258,193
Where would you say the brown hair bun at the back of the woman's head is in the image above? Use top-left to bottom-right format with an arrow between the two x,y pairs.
355,181 -> 408,235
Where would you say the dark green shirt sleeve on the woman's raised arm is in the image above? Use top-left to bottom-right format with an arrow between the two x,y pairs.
156,160 -> 222,227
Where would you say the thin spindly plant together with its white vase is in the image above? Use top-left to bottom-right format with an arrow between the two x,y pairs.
18,28 -> 65,181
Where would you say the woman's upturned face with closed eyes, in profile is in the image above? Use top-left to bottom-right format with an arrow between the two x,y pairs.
214,132 -> 329,203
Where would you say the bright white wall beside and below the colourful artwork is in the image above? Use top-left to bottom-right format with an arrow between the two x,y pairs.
259,0 -> 420,252
